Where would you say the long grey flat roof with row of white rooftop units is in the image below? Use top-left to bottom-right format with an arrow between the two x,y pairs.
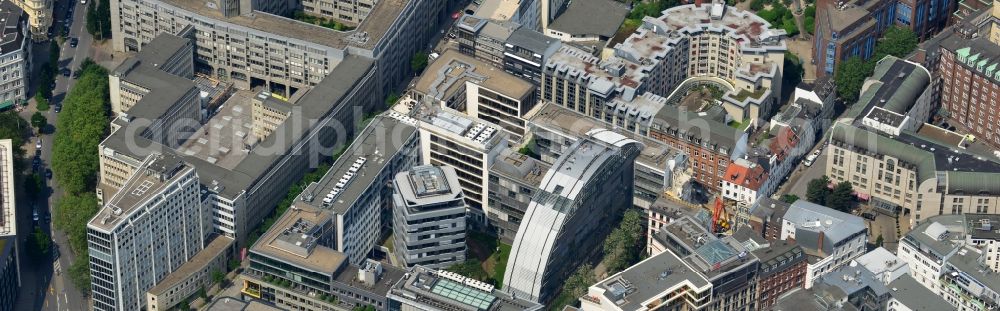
296,115 -> 417,215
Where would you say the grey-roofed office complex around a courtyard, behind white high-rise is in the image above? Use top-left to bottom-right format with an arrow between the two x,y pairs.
98,35 -> 383,246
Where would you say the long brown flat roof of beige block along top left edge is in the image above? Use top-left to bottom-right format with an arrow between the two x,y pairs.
159,0 -> 411,49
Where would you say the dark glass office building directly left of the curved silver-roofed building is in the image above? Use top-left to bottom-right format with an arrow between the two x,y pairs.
488,149 -> 550,244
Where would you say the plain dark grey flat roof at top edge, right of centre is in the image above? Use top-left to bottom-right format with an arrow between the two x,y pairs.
549,0 -> 629,38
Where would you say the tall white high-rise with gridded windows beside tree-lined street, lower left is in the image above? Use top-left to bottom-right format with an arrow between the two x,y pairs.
87,154 -> 212,310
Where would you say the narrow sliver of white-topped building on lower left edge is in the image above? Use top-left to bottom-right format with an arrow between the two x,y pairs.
0,139 -> 18,311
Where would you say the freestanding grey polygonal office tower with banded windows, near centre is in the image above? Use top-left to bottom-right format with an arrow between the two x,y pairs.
392,165 -> 466,268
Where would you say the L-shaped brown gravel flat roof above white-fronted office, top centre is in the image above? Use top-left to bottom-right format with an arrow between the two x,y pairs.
413,49 -> 534,99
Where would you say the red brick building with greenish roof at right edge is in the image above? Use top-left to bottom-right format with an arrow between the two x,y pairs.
938,36 -> 1000,148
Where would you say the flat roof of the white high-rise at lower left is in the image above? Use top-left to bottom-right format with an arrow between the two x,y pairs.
88,154 -> 194,232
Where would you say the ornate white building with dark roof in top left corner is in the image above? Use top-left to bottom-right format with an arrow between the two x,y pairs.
0,1 -> 27,109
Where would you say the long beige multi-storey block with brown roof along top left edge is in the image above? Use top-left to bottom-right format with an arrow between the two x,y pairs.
111,0 -> 445,99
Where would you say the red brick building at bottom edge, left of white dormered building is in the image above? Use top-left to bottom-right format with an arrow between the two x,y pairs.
753,241 -> 808,310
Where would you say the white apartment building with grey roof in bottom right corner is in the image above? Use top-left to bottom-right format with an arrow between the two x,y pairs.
897,214 -> 1000,310
